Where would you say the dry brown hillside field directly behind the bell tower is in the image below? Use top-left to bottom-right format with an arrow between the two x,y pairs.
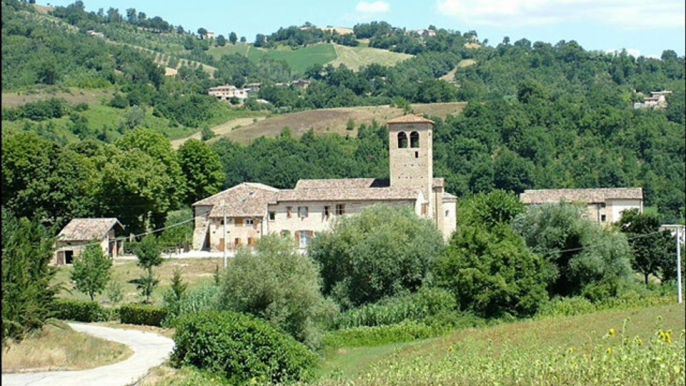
210,102 -> 466,144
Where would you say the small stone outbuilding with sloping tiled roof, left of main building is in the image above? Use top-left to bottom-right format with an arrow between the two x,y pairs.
53,218 -> 124,265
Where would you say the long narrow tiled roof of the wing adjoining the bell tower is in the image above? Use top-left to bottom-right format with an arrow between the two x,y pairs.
277,187 -> 419,202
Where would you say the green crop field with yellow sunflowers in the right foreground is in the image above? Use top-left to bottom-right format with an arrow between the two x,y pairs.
317,304 -> 685,385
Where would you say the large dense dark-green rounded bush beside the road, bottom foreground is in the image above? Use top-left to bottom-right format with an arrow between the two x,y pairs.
172,311 -> 317,383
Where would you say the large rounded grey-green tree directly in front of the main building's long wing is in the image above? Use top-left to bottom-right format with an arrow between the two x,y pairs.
308,205 -> 444,308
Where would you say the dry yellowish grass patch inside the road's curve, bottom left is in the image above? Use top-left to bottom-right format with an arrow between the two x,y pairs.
2,322 -> 133,373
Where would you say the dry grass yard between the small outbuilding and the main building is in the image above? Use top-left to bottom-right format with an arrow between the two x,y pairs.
53,258 -> 224,305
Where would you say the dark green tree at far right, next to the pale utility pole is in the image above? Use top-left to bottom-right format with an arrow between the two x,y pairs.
617,209 -> 675,285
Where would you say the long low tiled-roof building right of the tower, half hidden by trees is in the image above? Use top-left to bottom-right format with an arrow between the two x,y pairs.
519,188 -> 643,223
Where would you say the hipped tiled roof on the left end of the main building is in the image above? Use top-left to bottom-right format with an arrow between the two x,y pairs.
199,182 -> 279,217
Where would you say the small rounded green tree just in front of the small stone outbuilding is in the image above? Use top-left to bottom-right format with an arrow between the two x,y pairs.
71,244 -> 112,301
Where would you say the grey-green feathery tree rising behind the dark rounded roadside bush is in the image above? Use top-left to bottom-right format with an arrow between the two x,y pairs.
221,234 -> 335,348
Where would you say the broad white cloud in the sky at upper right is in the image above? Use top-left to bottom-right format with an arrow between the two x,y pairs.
437,0 -> 686,29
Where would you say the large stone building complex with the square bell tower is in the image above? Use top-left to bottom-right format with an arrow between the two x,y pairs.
193,115 -> 457,251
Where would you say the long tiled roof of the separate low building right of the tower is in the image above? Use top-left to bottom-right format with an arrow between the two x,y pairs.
519,188 -> 643,204
